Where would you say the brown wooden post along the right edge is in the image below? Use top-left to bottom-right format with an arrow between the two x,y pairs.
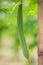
38,0 -> 43,65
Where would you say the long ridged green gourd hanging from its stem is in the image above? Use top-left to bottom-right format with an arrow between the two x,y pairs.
17,0 -> 29,59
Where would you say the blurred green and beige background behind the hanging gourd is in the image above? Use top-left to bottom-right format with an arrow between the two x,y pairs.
0,0 -> 38,65
